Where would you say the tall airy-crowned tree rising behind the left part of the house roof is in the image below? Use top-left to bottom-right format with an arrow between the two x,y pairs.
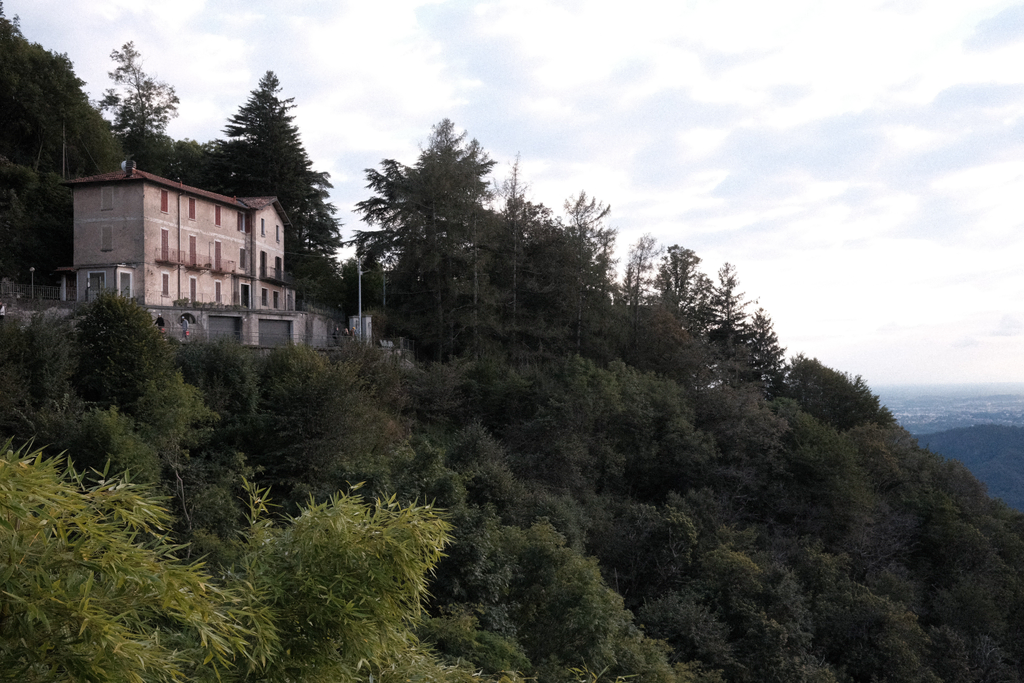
99,41 -> 178,175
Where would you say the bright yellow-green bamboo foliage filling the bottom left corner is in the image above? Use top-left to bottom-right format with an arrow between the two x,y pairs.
0,441 -> 256,682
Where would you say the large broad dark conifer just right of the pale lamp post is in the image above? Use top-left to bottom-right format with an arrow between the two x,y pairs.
355,119 -> 496,359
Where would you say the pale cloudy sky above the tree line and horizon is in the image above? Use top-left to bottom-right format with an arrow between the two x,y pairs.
4,0 -> 1024,385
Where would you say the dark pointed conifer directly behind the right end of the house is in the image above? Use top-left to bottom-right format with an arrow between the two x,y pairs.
204,71 -> 341,262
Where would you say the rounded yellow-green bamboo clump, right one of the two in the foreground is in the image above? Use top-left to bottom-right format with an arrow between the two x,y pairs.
243,483 -> 450,681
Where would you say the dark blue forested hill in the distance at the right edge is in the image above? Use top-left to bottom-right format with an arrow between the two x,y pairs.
918,425 -> 1024,512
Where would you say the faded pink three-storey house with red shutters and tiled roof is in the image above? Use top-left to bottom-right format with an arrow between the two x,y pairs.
68,162 -> 295,312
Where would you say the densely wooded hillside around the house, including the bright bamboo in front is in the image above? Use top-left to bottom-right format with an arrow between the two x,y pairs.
6,10 -> 1024,683
